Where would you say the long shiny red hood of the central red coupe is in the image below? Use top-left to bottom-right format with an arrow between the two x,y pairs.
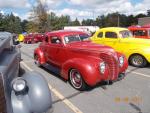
67,41 -> 115,53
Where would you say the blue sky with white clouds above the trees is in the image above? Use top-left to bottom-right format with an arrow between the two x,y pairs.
0,0 -> 150,20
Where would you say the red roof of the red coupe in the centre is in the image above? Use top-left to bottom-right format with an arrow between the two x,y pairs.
46,30 -> 87,36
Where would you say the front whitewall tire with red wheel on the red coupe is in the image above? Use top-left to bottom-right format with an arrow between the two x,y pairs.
69,69 -> 88,91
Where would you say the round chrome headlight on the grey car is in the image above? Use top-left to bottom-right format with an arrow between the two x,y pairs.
12,77 -> 27,94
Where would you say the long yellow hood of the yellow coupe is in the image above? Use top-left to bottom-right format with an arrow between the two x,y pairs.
121,38 -> 150,46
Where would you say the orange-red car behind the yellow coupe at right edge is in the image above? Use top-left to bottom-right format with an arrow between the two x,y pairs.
128,26 -> 150,39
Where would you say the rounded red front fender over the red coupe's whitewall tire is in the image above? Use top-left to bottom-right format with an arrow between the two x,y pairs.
61,58 -> 104,85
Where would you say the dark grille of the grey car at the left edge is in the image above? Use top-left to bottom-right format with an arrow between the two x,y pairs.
0,75 -> 7,113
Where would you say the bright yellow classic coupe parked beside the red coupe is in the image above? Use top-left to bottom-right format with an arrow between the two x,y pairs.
90,27 -> 150,67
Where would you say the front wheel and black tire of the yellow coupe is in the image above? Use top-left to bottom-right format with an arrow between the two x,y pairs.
129,54 -> 147,67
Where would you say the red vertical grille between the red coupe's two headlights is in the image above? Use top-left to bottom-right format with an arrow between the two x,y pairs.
100,53 -> 119,80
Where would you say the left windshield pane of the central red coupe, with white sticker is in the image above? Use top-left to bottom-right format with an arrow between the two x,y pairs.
64,35 -> 81,44
